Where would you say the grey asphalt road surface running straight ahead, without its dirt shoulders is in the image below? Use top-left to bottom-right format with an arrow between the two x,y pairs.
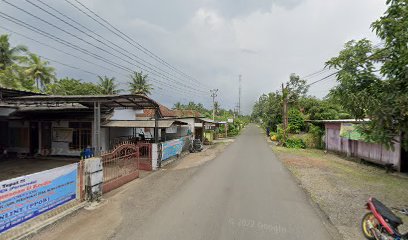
110,125 -> 331,240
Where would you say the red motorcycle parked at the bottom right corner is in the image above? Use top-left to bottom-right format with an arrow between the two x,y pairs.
361,198 -> 408,240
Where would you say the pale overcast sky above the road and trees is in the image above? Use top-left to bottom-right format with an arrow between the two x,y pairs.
0,0 -> 385,112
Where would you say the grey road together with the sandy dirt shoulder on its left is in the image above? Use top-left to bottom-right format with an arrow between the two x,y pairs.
28,125 -> 338,240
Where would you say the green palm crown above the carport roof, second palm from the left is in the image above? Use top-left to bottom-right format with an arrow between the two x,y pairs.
24,53 -> 55,89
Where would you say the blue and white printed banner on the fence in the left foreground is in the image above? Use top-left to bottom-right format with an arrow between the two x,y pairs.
0,163 -> 78,233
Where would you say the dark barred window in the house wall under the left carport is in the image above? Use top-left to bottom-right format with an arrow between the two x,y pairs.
69,122 -> 92,150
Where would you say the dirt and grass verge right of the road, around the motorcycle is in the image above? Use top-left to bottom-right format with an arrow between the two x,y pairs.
273,146 -> 408,240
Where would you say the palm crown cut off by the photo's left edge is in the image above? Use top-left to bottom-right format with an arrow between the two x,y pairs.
0,34 -> 28,70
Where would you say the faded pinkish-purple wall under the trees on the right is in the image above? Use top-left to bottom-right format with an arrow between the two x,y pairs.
325,123 -> 401,171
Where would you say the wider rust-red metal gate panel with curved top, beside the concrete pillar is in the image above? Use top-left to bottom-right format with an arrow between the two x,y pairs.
101,142 -> 139,193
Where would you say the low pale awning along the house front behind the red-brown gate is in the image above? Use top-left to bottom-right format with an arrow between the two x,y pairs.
101,120 -> 187,128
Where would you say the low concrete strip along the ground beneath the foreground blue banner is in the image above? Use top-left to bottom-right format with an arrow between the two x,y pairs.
12,202 -> 88,240
